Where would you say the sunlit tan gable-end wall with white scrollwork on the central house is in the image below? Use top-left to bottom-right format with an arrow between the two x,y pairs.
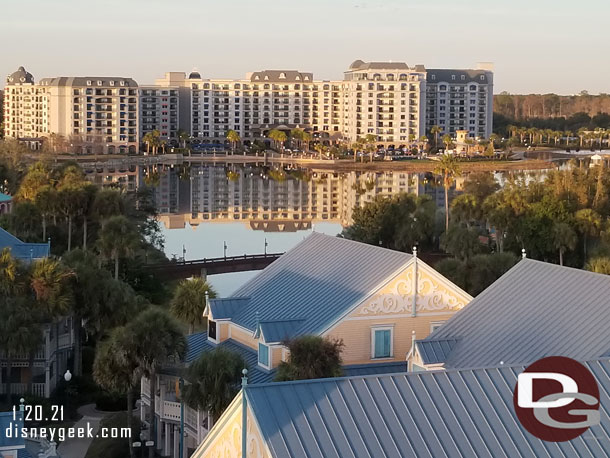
324,260 -> 472,364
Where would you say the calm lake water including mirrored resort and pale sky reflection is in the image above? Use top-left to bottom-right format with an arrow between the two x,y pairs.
86,162 -> 544,296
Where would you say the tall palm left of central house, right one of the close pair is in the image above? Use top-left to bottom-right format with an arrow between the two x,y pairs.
126,308 -> 186,458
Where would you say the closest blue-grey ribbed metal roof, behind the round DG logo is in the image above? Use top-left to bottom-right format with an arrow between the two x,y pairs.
243,360 -> 610,458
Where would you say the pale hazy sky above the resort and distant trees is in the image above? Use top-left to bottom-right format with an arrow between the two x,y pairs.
0,0 -> 610,94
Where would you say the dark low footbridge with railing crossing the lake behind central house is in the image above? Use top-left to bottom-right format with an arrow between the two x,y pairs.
146,253 -> 284,280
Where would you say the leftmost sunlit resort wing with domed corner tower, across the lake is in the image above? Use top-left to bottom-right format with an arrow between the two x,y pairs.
4,67 -> 139,153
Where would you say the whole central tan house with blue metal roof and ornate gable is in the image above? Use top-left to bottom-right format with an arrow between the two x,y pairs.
141,232 -> 472,456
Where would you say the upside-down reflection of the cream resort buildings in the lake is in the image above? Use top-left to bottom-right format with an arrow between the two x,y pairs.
86,163 -> 463,232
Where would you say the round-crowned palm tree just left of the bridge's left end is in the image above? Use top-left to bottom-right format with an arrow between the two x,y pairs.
97,215 -> 141,280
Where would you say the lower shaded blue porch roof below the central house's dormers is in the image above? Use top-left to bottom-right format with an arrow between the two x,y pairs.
184,332 -> 275,383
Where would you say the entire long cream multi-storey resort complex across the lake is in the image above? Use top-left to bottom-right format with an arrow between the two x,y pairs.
4,60 -> 493,153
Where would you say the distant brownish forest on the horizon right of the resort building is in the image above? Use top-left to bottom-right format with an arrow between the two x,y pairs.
494,91 -> 610,136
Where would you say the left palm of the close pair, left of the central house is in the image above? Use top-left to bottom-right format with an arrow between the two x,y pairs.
93,326 -> 141,457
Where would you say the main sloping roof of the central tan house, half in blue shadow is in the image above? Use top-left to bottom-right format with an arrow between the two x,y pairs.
213,232 -> 412,335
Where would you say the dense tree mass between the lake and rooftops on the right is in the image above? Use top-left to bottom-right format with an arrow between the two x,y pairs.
342,158 -> 610,295
